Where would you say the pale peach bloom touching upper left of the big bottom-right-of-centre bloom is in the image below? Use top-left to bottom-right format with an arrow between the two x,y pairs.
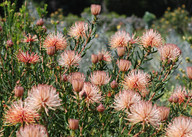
114,90 -> 141,111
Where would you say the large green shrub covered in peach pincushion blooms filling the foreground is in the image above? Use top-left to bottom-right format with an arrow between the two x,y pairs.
0,1 -> 192,137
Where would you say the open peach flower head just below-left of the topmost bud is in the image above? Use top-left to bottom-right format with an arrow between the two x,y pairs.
68,21 -> 88,39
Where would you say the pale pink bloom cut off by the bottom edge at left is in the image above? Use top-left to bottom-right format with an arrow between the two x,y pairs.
16,124 -> 48,137
